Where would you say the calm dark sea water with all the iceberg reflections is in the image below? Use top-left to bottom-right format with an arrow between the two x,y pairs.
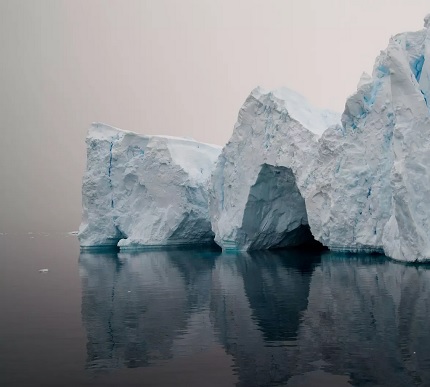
0,234 -> 430,387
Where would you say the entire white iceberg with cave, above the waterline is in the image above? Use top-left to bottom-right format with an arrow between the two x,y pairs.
79,15 -> 430,261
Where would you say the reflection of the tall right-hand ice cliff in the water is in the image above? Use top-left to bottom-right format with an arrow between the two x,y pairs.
297,254 -> 430,386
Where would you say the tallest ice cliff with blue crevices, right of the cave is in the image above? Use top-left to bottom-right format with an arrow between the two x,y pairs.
305,17 -> 430,261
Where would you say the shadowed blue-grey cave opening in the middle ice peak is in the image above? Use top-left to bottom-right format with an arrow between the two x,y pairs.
242,164 -> 322,250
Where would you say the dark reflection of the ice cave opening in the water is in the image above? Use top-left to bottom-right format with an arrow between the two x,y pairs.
237,250 -> 320,342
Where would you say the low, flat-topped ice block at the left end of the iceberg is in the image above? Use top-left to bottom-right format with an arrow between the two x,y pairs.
78,123 -> 221,249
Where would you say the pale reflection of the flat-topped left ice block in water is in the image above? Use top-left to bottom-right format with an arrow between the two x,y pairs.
79,251 -> 217,368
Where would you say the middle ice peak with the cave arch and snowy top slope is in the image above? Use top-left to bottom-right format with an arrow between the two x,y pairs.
209,88 -> 340,250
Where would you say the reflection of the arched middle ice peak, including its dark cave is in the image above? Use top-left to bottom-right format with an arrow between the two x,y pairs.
211,251 -> 318,386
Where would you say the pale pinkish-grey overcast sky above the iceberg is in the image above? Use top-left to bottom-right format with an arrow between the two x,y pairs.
0,0 -> 430,232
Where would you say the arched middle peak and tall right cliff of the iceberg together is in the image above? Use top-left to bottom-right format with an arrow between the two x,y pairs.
210,16 -> 430,261
